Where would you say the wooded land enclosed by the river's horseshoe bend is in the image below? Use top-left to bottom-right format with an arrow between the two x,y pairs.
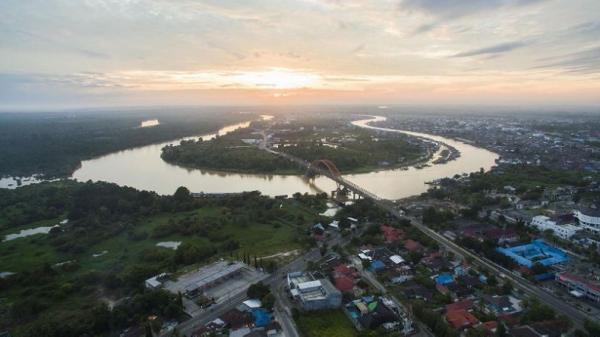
162,121 -> 424,174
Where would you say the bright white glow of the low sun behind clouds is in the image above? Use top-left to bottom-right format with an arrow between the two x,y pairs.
232,69 -> 321,89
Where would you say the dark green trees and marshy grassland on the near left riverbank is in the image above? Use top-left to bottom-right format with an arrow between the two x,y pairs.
0,181 -> 325,337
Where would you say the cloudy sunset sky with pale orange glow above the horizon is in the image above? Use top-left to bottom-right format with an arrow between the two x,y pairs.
0,0 -> 600,110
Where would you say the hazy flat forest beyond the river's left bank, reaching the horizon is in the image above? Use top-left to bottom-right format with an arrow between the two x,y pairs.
0,110 -> 253,178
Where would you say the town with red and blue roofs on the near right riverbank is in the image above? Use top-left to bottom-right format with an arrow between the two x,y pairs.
132,114 -> 600,337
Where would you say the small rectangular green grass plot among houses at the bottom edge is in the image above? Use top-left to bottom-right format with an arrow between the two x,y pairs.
296,310 -> 358,337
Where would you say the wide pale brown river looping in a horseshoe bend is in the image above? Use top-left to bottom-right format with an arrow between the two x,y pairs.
73,117 -> 498,199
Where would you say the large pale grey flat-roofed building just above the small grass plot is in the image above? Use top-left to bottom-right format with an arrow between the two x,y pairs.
287,272 -> 342,310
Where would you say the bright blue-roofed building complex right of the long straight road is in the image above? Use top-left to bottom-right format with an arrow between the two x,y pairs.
496,240 -> 569,268
